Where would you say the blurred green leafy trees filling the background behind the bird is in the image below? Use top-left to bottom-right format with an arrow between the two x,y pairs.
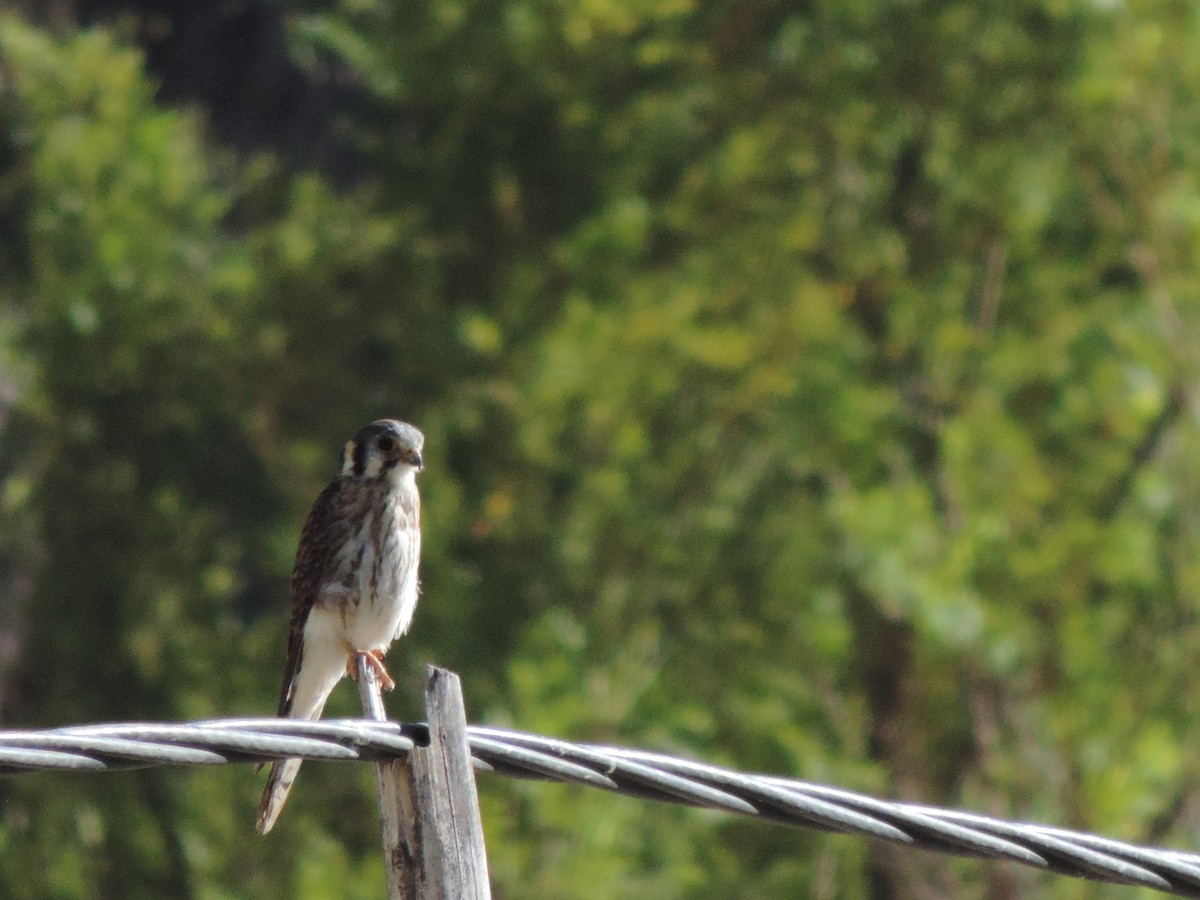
0,0 -> 1200,900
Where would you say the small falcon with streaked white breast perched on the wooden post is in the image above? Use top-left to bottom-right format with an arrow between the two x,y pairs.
257,419 -> 425,834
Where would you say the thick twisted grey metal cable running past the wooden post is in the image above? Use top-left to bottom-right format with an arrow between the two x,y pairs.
0,719 -> 1200,898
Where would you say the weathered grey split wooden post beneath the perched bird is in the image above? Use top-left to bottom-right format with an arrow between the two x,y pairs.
359,659 -> 492,900
